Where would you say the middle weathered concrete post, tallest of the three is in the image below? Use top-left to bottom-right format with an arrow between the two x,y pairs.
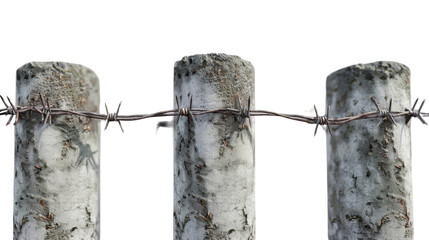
174,54 -> 255,240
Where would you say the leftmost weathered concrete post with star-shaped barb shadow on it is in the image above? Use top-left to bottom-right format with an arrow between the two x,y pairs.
14,62 -> 100,240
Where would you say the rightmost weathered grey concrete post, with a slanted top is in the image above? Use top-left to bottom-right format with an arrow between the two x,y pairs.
326,62 -> 413,240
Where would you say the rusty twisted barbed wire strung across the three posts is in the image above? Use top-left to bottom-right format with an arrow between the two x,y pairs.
0,94 -> 429,135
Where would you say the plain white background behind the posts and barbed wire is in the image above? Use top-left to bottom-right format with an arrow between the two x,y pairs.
0,0 -> 429,240
